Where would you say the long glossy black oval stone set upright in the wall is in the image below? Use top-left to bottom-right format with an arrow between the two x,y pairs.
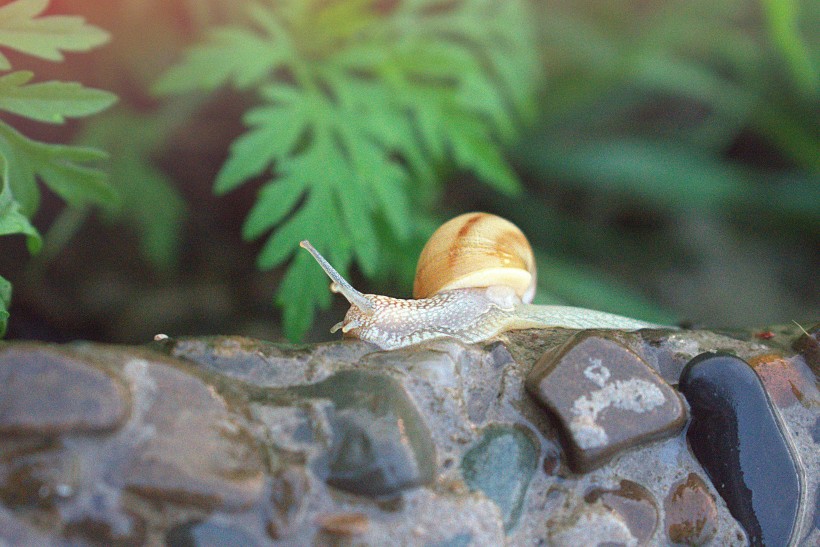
680,353 -> 802,546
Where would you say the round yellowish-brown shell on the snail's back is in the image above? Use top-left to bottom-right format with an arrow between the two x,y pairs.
413,213 -> 536,303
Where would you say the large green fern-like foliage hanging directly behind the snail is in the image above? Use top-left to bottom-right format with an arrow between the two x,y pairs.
155,0 -> 538,339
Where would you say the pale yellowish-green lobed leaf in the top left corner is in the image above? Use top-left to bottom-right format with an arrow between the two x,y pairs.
0,0 -> 109,70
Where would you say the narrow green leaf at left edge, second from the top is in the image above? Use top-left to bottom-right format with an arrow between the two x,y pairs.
0,71 -> 117,123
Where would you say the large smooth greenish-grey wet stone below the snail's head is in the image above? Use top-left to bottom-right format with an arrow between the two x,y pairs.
288,370 -> 436,496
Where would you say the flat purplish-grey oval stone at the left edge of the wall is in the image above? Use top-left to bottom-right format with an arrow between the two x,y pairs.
0,345 -> 129,435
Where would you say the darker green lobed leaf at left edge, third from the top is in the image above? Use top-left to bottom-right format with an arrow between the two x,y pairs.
0,122 -> 119,216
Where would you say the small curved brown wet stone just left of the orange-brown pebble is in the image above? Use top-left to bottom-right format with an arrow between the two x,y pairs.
584,480 -> 658,544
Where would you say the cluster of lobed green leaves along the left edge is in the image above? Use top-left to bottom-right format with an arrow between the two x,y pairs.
0,0 -> 117,336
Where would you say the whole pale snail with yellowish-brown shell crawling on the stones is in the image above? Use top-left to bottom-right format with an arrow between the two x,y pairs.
300,213 -> 663,350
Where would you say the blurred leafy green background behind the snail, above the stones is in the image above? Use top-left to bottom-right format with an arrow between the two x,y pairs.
0,0 -> 820,341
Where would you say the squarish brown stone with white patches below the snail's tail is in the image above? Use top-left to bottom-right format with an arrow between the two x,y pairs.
527,332 -> 686,472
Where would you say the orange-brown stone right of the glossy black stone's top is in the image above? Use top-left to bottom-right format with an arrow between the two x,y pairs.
748,353 -> 820,408
